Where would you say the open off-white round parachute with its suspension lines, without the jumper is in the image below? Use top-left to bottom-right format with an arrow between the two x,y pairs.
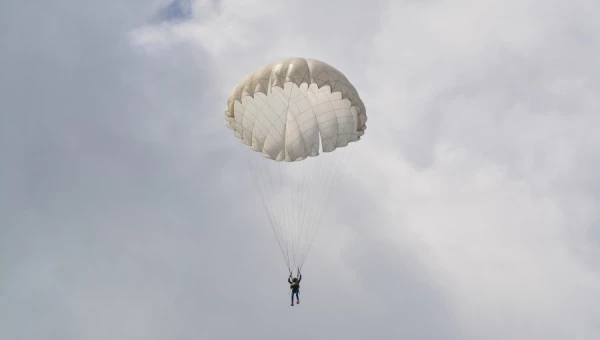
225,58 -> 367,273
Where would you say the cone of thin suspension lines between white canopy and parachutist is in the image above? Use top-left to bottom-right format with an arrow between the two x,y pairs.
244,135 -> 355,273
